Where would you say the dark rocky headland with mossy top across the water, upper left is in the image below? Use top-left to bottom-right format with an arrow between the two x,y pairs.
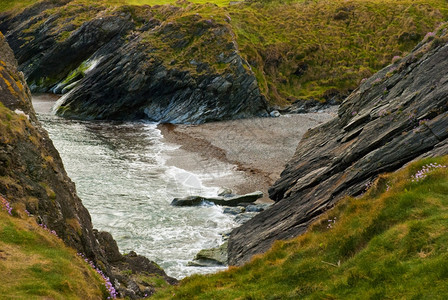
0,1 -> 267,123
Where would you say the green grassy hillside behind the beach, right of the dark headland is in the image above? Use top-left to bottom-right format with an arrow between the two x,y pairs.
0,0 -> 448,104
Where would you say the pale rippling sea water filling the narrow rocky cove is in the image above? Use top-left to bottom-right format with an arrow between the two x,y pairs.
33,97 -> 237,278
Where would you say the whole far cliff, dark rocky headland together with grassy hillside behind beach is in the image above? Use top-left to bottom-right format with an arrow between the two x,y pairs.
0,0 -> 448,123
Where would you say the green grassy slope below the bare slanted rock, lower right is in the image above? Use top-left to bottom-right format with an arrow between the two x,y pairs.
155,156 -> 448,299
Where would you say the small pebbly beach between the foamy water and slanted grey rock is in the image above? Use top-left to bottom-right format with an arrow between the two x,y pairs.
158,107 -> 337,202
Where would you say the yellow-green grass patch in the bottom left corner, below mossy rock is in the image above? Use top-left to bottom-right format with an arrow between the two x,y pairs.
0,204 -> 107,299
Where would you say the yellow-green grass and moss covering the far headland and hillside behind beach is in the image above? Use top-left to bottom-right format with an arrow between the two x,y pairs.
3,0 -> 448,111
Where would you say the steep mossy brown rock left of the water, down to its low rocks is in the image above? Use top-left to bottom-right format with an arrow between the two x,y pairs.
0,32 -> 175,298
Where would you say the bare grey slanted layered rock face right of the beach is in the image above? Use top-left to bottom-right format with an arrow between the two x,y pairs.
229,25 -> 448,265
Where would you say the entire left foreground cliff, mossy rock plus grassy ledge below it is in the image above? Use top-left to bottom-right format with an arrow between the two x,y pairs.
0,25 -> 176,299
